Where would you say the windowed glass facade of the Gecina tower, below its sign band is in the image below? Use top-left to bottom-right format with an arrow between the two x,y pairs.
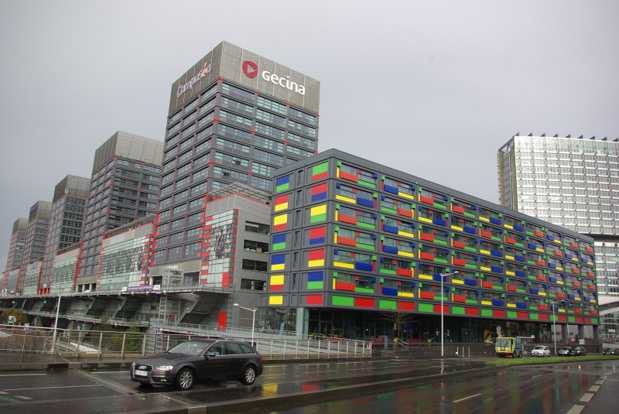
154,44 -> 318,272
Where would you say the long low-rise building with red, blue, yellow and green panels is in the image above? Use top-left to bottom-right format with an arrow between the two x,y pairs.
266,149 -> 599,341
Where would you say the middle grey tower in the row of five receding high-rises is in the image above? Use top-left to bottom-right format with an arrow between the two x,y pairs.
38,175 -> 90,294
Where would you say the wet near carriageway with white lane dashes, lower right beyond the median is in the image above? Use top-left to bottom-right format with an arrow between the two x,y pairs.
270,361 -> 619,414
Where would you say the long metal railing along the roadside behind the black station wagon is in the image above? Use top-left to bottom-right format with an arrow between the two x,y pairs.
0,325 -> 372,359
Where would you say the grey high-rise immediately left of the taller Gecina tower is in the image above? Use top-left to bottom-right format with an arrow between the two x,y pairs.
76,131 -> 163,291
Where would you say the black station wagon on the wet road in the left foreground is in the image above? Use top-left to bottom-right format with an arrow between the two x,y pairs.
131,339 -> 263,391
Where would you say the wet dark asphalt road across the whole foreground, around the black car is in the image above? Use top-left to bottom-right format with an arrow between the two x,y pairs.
0,359 -> 619,414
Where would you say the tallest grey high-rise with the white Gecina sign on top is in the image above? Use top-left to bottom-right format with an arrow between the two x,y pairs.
151,42 -> 320,283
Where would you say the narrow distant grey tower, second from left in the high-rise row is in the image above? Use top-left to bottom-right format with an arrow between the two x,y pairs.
16,201 -> 52,292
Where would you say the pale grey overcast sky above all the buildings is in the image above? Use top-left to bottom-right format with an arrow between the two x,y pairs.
0,0 -> 619,271
